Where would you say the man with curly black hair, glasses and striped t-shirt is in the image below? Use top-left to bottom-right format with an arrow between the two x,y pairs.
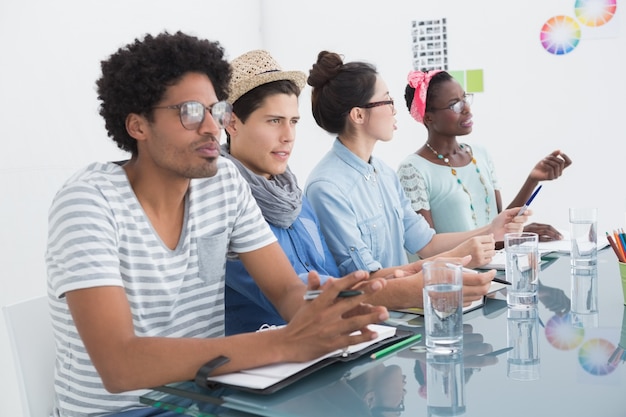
46,32 -> 388,417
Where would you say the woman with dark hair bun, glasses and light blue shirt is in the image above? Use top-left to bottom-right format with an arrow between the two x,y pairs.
305,51 -> 527,274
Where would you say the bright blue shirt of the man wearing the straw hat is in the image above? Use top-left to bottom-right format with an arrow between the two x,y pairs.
225,196 -> 339,335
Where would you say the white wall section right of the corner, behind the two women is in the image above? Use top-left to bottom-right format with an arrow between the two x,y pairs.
265,0 -> 626,238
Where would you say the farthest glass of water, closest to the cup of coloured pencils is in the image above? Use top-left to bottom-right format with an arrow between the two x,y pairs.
569,208 -> 598,269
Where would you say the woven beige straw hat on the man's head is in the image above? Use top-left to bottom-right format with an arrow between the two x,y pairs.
228,49 -> 306,104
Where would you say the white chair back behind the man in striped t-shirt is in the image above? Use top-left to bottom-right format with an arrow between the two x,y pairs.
2,296 -> 55,417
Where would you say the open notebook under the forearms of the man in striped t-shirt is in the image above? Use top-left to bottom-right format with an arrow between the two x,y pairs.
199,324 -> 412,394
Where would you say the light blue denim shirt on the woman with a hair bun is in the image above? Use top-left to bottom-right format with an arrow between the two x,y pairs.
304,139 -> 435,275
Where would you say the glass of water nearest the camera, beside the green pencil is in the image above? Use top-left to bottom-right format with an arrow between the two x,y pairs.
423,259 -> 463,354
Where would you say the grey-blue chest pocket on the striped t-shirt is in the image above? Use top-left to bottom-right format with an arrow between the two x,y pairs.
198,229 -> 230,284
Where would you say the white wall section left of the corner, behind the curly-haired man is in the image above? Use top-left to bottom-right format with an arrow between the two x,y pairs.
0,0 -> 262,416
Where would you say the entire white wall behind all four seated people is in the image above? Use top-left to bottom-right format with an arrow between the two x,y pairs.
0,0 -> 626,416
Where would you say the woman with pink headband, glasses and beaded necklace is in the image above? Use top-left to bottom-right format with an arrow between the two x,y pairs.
398,70 -> 572,240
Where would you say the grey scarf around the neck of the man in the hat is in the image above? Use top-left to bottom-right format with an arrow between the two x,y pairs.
221,143 -> 302,229
